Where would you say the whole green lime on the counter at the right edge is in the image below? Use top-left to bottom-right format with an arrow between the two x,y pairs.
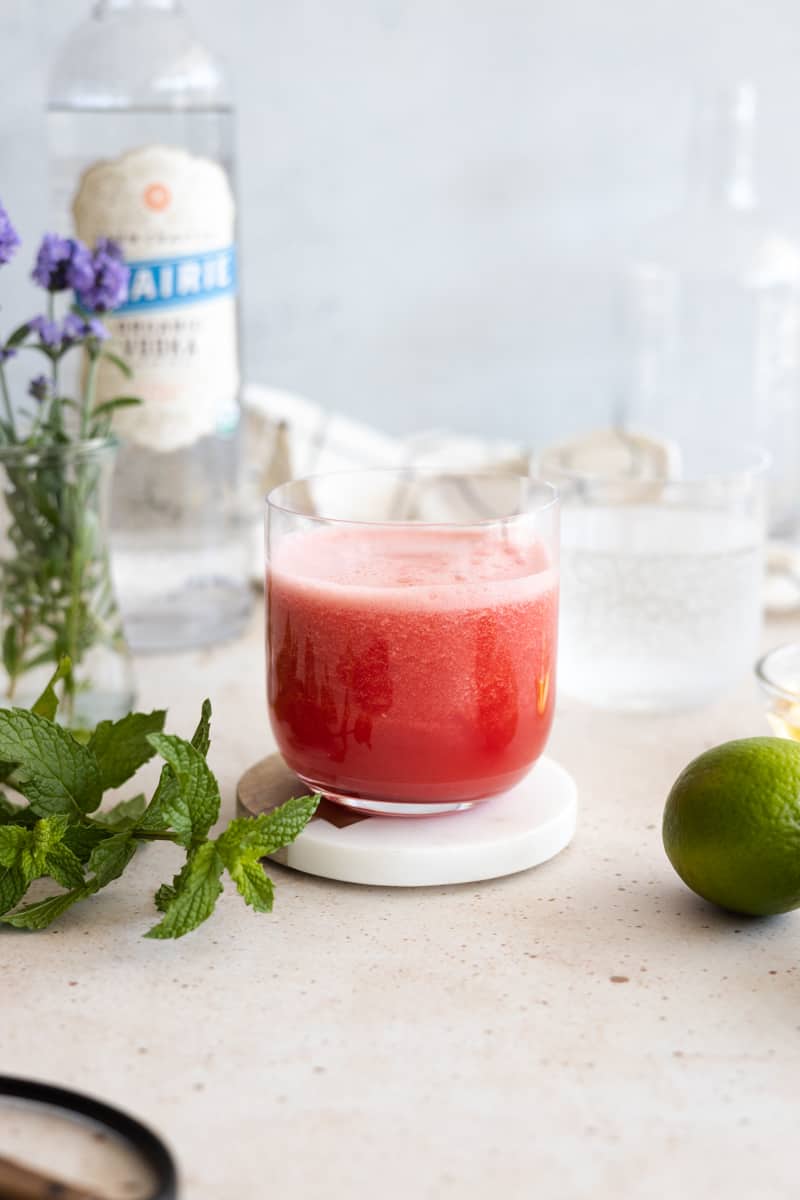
663,738 -> 800,917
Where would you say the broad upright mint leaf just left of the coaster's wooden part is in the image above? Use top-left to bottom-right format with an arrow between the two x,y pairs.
143,733 -> 219,847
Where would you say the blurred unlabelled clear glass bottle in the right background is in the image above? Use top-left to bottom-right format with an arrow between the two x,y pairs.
625,83 -> 800,535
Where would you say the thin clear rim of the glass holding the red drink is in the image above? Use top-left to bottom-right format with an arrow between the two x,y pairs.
264,467 -> 559,529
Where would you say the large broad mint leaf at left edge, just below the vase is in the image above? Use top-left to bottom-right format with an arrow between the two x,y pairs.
0,708 -> 103,815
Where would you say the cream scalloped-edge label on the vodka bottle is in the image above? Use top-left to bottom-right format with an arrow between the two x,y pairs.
73,145 -> 239,451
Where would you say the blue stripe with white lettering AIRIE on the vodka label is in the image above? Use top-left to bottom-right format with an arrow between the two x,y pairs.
114,246 -> 237,317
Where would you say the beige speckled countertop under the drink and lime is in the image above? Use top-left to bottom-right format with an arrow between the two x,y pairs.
0,622 -> 800,1200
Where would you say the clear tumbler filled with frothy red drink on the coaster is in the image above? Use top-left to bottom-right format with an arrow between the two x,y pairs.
266,470 -> 558,815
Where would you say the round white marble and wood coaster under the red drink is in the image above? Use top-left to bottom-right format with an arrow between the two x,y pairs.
237,755 -> 578,888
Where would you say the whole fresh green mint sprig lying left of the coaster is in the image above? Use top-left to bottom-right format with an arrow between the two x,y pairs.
0,662 -> 319,938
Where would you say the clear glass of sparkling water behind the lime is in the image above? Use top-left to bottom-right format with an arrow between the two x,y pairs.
552,450 -> 768,712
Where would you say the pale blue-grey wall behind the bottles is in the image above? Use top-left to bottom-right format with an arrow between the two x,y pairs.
0,0 -> 800,442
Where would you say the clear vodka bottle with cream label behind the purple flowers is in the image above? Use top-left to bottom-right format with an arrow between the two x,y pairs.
48,0 -> 252,650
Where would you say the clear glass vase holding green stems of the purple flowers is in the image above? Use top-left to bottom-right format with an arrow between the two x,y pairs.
0,438 -> 134,730
